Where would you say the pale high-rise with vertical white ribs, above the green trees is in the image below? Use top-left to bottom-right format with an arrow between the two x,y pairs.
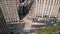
30,0 -> 60,18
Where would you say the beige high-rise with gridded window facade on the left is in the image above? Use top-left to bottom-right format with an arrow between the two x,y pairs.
0,0 -> 19,23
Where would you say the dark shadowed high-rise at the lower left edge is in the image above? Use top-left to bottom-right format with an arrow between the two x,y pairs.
0,7 -> 8,34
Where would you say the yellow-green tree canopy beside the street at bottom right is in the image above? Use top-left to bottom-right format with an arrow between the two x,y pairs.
37,26 -> 60,34
